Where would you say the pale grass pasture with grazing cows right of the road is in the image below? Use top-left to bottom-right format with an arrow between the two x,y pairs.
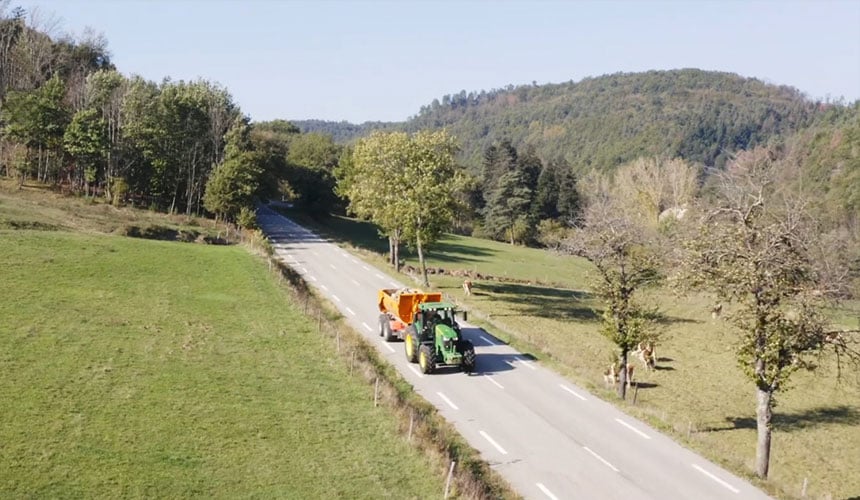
290,211 -> 860,498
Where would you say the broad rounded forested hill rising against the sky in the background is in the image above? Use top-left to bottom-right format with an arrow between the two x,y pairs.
406,69 -> 818,170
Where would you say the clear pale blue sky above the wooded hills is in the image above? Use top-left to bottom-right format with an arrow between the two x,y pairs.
18,0 -> 860,122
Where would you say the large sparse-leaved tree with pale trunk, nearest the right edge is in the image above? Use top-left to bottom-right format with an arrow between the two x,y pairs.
678,149 -> 860,478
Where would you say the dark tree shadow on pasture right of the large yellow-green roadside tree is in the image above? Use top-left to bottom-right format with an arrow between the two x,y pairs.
478,282 -> 602,321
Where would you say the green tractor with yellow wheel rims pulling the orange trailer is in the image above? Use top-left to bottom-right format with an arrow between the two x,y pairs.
404,302 -> 475,373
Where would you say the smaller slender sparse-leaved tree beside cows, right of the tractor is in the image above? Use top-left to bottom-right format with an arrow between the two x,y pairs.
561,174 -> 659,399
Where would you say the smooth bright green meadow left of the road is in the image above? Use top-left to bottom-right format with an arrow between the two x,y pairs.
0,229 -> 444,498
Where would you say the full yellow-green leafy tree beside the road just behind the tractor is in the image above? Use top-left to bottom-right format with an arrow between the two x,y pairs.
336,131 -> 458,286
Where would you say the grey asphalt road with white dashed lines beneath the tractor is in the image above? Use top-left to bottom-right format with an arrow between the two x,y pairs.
258,208 -> 768,500
